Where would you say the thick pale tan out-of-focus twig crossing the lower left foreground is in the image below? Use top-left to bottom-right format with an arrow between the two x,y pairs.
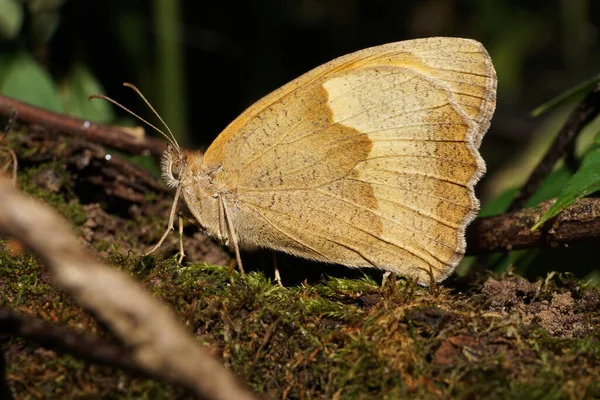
0,178 -> 255,400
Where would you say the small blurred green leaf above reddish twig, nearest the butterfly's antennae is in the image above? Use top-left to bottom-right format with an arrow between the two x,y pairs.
58,63 -> 115,123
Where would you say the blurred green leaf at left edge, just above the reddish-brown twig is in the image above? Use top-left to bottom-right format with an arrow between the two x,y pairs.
0,52 -> 62,112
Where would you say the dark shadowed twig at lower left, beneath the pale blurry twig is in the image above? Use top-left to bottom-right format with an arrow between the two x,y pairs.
0,308 -> 142,376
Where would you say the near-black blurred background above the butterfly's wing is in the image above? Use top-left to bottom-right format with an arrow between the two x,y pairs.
52,0 -> 600,145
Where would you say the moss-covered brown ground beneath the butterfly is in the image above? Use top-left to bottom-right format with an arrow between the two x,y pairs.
0,135 -> 600,399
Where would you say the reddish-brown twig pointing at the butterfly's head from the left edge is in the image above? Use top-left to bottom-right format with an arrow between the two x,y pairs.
0,96 -> 167,155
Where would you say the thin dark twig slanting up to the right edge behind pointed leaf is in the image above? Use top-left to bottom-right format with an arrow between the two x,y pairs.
508,84 -> 600,212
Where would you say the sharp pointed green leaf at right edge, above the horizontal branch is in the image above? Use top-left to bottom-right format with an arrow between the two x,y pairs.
531,133 -> 600,230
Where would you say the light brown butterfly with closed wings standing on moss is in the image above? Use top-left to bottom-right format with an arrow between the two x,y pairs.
126,37 -> 496,285
